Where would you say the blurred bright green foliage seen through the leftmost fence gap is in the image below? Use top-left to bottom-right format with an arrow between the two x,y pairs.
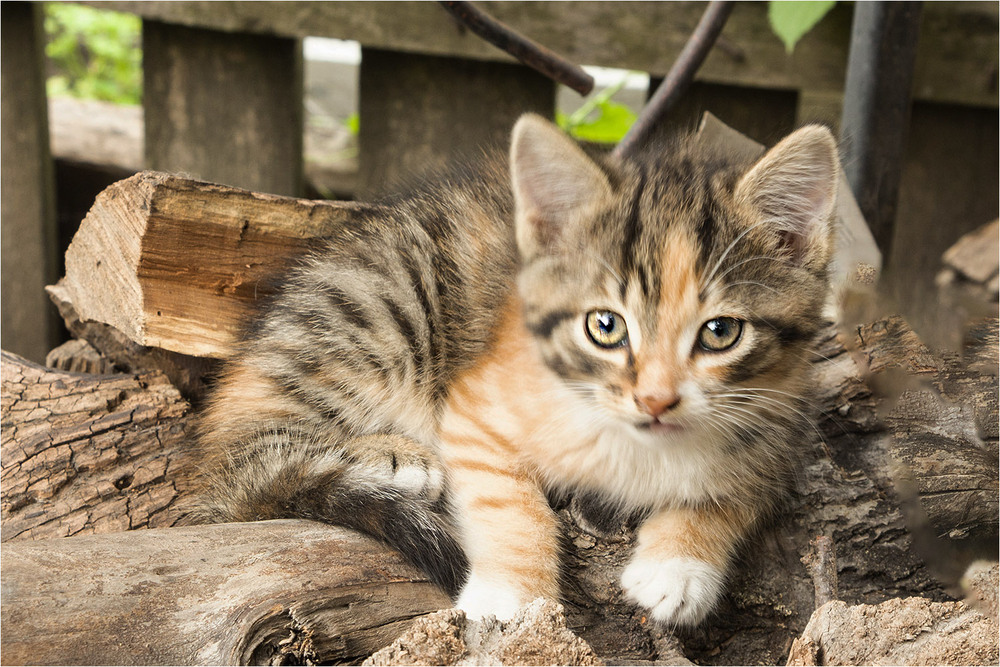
45,2 -> 142,104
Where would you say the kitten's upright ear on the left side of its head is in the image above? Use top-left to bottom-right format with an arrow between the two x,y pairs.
510,114 -> 611,259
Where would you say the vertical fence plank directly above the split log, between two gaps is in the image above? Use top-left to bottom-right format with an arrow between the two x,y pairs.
142,21 -> 303,196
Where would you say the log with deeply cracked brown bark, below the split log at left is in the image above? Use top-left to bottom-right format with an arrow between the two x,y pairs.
0,352 -> 196,544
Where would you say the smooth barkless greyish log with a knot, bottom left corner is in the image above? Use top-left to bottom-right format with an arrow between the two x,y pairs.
0,521 -> 449,665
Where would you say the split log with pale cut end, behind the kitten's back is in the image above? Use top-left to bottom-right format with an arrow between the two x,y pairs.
49,172 -> 372,357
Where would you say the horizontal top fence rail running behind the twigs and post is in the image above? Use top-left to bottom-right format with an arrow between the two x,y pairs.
89,1 -> 998,109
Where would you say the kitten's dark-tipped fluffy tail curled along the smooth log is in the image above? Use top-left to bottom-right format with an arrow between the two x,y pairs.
188,431 -> 468,597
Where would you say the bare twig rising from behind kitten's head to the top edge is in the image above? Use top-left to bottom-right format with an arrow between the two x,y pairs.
614,0 -> 734,157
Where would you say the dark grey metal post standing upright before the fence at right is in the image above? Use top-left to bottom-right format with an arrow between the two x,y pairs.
840,1 -> 920,264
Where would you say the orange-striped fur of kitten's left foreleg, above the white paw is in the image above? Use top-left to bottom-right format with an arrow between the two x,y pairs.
441,298 -> 559,600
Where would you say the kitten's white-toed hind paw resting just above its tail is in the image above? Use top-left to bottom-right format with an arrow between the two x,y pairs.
351,435 -> 444,501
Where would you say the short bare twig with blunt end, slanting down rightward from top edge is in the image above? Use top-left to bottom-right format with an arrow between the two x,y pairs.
440,2 -> 594,95
